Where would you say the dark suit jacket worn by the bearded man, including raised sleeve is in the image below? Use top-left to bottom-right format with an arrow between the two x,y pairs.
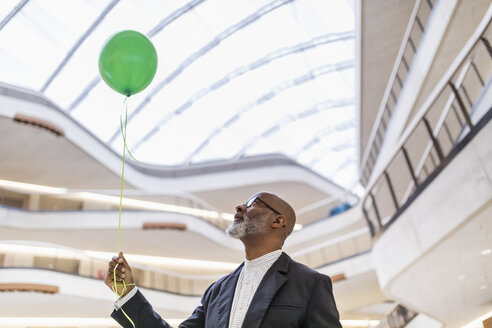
111,253 -> 342,328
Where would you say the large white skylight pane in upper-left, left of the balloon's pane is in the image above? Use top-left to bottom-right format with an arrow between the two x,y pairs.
0,0 -> 109,90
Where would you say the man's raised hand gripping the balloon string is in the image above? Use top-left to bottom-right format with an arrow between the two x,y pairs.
104,252 -> 135,297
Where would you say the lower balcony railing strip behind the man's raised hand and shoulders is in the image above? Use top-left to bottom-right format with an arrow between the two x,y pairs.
0,224 -> 372,296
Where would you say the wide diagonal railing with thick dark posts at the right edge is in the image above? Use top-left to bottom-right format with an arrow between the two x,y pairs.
362,8 -> 492,236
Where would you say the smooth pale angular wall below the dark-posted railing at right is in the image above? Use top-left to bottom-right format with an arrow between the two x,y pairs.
372,115 -> 492,327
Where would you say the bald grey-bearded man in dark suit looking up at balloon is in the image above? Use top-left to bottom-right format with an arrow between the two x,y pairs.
105,192 -> 342,328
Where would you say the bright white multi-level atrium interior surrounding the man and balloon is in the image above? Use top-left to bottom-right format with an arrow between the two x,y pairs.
0,0 -> 492,328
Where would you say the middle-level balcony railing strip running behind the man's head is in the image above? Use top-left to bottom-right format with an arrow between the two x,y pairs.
0,185 -> 358,231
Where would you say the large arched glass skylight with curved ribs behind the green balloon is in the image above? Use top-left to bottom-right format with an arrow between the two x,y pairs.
0,0 -> 357,187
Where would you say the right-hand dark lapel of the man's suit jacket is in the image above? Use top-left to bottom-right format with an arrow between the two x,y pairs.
242,253 -> 290,328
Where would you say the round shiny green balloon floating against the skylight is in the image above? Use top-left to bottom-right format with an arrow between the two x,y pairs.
99,30 -> 157,96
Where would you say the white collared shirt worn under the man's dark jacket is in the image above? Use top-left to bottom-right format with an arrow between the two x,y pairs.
229,249 -> 282,328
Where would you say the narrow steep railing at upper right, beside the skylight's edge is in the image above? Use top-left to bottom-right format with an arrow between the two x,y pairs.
360,0 -> 434,186
